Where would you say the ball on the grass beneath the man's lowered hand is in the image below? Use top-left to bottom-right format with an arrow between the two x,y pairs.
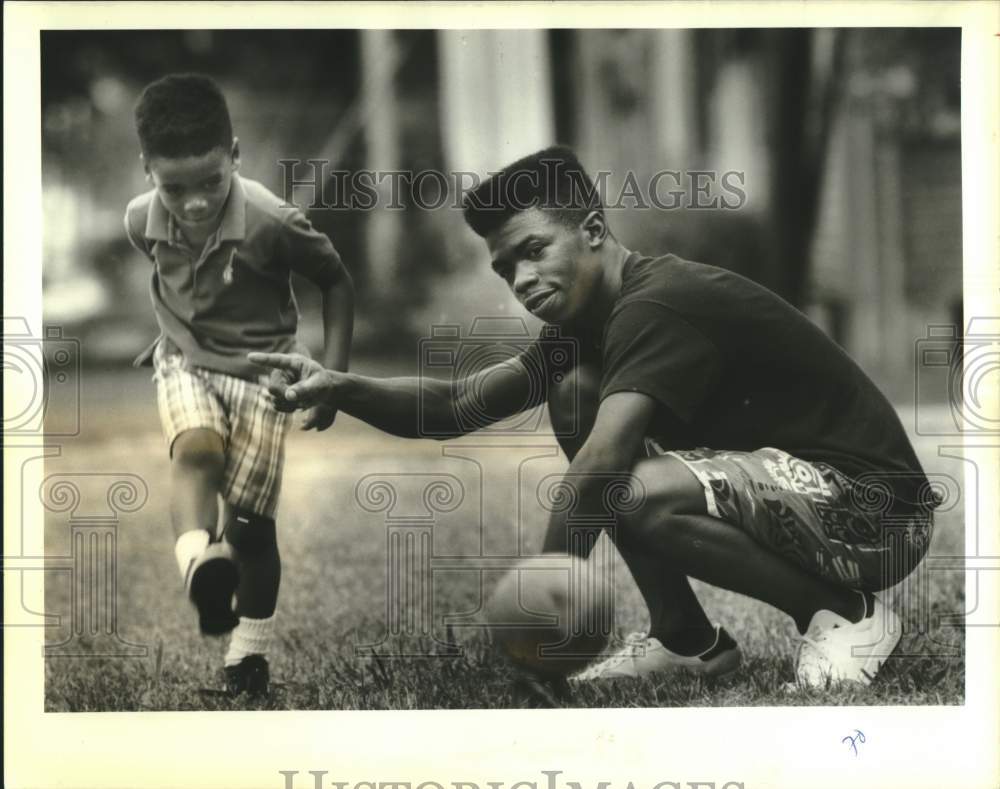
485,554 -> 614,677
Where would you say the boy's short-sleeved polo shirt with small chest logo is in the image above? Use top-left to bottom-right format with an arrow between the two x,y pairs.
125,175 -> 344,380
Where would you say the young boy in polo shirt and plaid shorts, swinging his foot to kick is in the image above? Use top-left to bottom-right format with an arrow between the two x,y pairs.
125,74 -> 354,695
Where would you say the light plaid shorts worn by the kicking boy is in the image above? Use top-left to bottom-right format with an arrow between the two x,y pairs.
153,342 -> 291,518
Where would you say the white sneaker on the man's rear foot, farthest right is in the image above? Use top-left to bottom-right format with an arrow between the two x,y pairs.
795,595 -> 902,688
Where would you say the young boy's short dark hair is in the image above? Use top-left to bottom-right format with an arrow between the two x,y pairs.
135,74 -> 233,159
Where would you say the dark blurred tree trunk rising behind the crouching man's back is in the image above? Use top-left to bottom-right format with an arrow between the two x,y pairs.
764,29 -> 844,306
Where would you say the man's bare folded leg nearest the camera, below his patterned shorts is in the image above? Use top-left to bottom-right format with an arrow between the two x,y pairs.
619,455 -> 865,633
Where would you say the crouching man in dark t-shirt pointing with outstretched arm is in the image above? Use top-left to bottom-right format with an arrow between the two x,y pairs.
251,148 -> 934,686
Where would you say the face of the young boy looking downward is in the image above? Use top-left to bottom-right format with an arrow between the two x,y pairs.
144,142 -> 240,230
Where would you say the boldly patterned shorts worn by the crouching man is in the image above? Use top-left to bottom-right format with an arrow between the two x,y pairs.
646,439 -> 933,591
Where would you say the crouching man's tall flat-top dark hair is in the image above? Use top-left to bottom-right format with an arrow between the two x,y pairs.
463,145 -> 604,238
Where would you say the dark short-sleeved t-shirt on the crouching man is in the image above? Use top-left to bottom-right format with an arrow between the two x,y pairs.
540,253 -> 927,510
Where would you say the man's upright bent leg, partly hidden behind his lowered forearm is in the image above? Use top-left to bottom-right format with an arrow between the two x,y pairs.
549,367 -> 716,655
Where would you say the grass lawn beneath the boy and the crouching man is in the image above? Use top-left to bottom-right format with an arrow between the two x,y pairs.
45,371 -> 965,711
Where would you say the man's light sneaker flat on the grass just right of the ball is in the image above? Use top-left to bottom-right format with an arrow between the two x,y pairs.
569,625 -> 741,682
